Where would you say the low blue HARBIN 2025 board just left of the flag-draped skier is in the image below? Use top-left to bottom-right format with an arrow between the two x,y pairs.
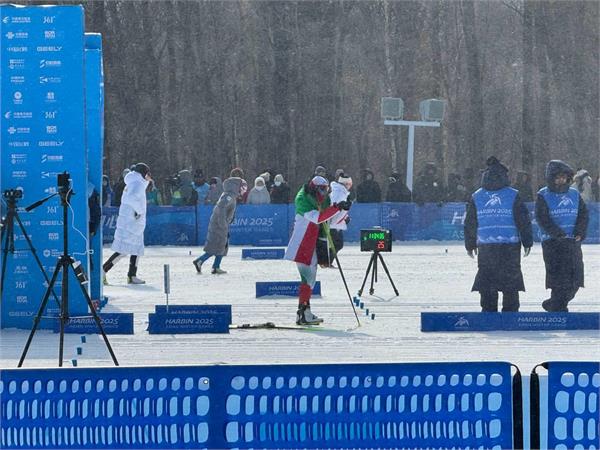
148,313 -> 231,334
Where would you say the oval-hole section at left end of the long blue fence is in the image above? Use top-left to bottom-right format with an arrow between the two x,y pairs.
0,377 -> 210,448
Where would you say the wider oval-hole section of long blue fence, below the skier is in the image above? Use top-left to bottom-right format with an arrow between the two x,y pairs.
226,373 -> 504,448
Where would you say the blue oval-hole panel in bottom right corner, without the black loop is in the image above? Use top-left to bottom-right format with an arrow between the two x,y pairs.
547,362 -> 600,450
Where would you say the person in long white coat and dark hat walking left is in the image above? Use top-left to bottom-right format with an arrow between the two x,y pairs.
102,163 -> 151,284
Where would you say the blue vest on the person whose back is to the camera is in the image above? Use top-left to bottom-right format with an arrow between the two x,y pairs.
473,187 -> 521,245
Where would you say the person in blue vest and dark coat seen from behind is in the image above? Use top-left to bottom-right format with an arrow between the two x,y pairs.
465,156 -> 533,312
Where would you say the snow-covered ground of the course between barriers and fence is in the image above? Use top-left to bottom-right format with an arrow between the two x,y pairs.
0,242 -> 600,374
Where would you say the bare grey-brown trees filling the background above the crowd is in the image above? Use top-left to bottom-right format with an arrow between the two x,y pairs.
35,0 -> 600,191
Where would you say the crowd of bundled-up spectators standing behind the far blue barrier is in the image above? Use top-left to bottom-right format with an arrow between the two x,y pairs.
102,162 -> 600,206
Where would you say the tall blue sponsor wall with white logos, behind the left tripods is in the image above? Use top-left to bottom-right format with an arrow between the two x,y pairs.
0,5 -> 88,328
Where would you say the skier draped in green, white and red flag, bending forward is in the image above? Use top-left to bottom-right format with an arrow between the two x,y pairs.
284,175 -> 350,325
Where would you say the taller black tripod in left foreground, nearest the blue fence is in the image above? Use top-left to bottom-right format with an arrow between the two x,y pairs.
17,179 -> 119,367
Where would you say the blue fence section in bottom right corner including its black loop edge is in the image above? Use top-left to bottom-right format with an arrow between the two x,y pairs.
530,362 -> 600,450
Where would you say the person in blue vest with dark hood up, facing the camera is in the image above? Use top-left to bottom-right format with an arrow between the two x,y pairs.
535,160 -> 588,312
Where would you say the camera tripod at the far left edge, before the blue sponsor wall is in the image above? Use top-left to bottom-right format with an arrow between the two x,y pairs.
0,189 -> 60,306
